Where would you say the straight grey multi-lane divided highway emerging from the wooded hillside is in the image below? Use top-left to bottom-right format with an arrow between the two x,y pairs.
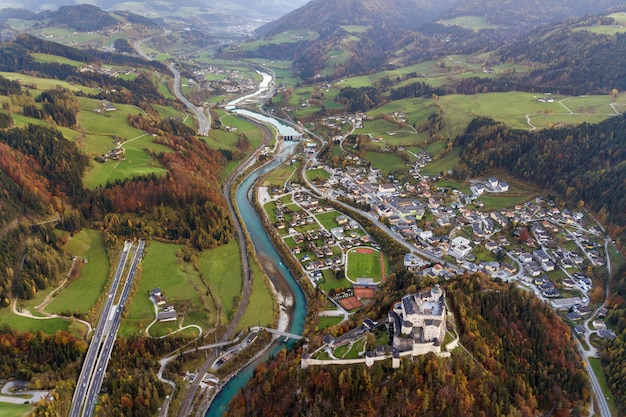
69,240 -> 145,417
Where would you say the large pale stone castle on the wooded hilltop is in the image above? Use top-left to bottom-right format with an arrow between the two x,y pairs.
389,284 -> 446,356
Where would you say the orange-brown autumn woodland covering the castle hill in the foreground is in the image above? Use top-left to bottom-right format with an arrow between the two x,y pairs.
227,276 -> 589,416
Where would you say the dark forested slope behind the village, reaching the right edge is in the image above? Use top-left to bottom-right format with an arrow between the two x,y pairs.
455,116 -> 626,244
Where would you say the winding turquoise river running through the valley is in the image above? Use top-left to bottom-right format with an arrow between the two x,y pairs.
205,73 -> 306,417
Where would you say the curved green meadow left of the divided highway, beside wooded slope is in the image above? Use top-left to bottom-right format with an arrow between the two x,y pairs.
46,229 -> 109,313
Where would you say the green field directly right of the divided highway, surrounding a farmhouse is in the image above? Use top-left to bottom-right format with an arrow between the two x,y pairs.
120,241 -> 213,336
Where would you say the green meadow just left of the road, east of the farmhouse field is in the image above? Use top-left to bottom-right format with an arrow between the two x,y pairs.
198,241 -> 243,323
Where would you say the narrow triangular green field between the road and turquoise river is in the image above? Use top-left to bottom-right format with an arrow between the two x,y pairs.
237,255 -> 274,331
